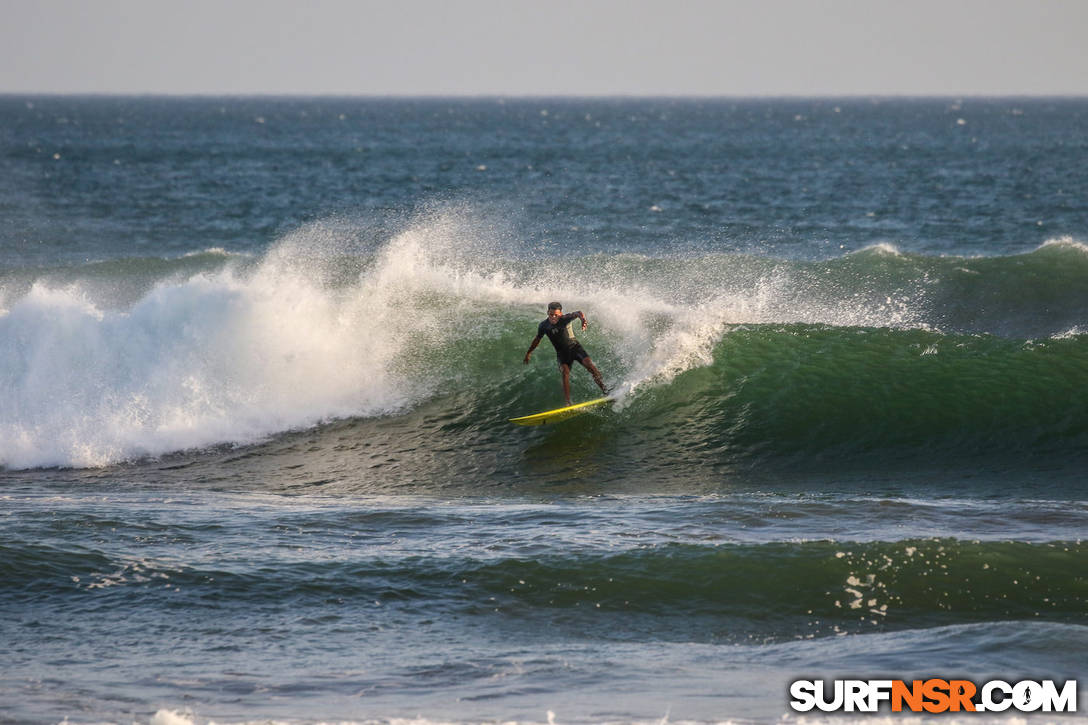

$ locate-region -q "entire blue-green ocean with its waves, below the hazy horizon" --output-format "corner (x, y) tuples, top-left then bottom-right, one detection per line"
(0, 96), (1088, 725)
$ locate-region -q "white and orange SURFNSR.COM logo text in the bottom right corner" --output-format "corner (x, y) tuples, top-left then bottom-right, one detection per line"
(790, 677), (1077, 713)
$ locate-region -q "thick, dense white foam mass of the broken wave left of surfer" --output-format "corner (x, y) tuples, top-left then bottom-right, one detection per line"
(0, 218), (485, 468)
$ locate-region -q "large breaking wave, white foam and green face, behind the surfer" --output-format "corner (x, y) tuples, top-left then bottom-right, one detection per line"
(0, 210), (1088, 468)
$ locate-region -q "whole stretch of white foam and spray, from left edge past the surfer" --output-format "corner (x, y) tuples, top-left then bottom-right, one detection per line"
(0, 209), (935, 468)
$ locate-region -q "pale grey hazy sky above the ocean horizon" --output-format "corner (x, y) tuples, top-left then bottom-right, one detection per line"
(0, 0), (1088, 96)
